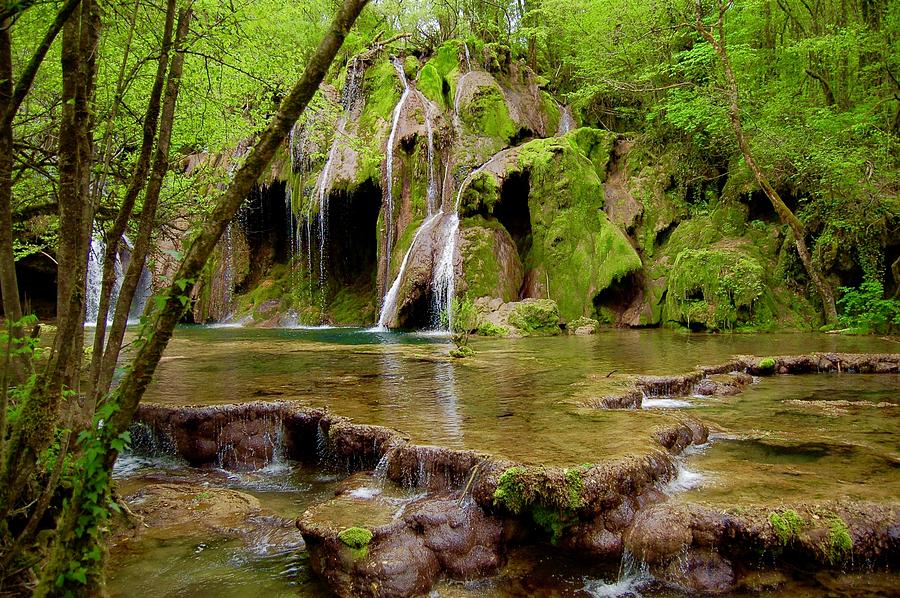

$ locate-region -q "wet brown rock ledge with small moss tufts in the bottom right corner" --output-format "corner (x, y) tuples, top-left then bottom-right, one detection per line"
(625, 502), (900, 592)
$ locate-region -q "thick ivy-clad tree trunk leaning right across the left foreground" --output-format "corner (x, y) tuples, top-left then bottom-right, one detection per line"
(37, 0), (368, 596)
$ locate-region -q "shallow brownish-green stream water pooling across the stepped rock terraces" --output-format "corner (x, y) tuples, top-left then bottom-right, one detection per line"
(109, 326), (900, 597)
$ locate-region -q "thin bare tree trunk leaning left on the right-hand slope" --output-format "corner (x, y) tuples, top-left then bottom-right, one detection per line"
(695, 2), (837, 324)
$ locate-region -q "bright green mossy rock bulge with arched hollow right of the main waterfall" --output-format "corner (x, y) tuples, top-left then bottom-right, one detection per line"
(461, 129), (641, 319)
